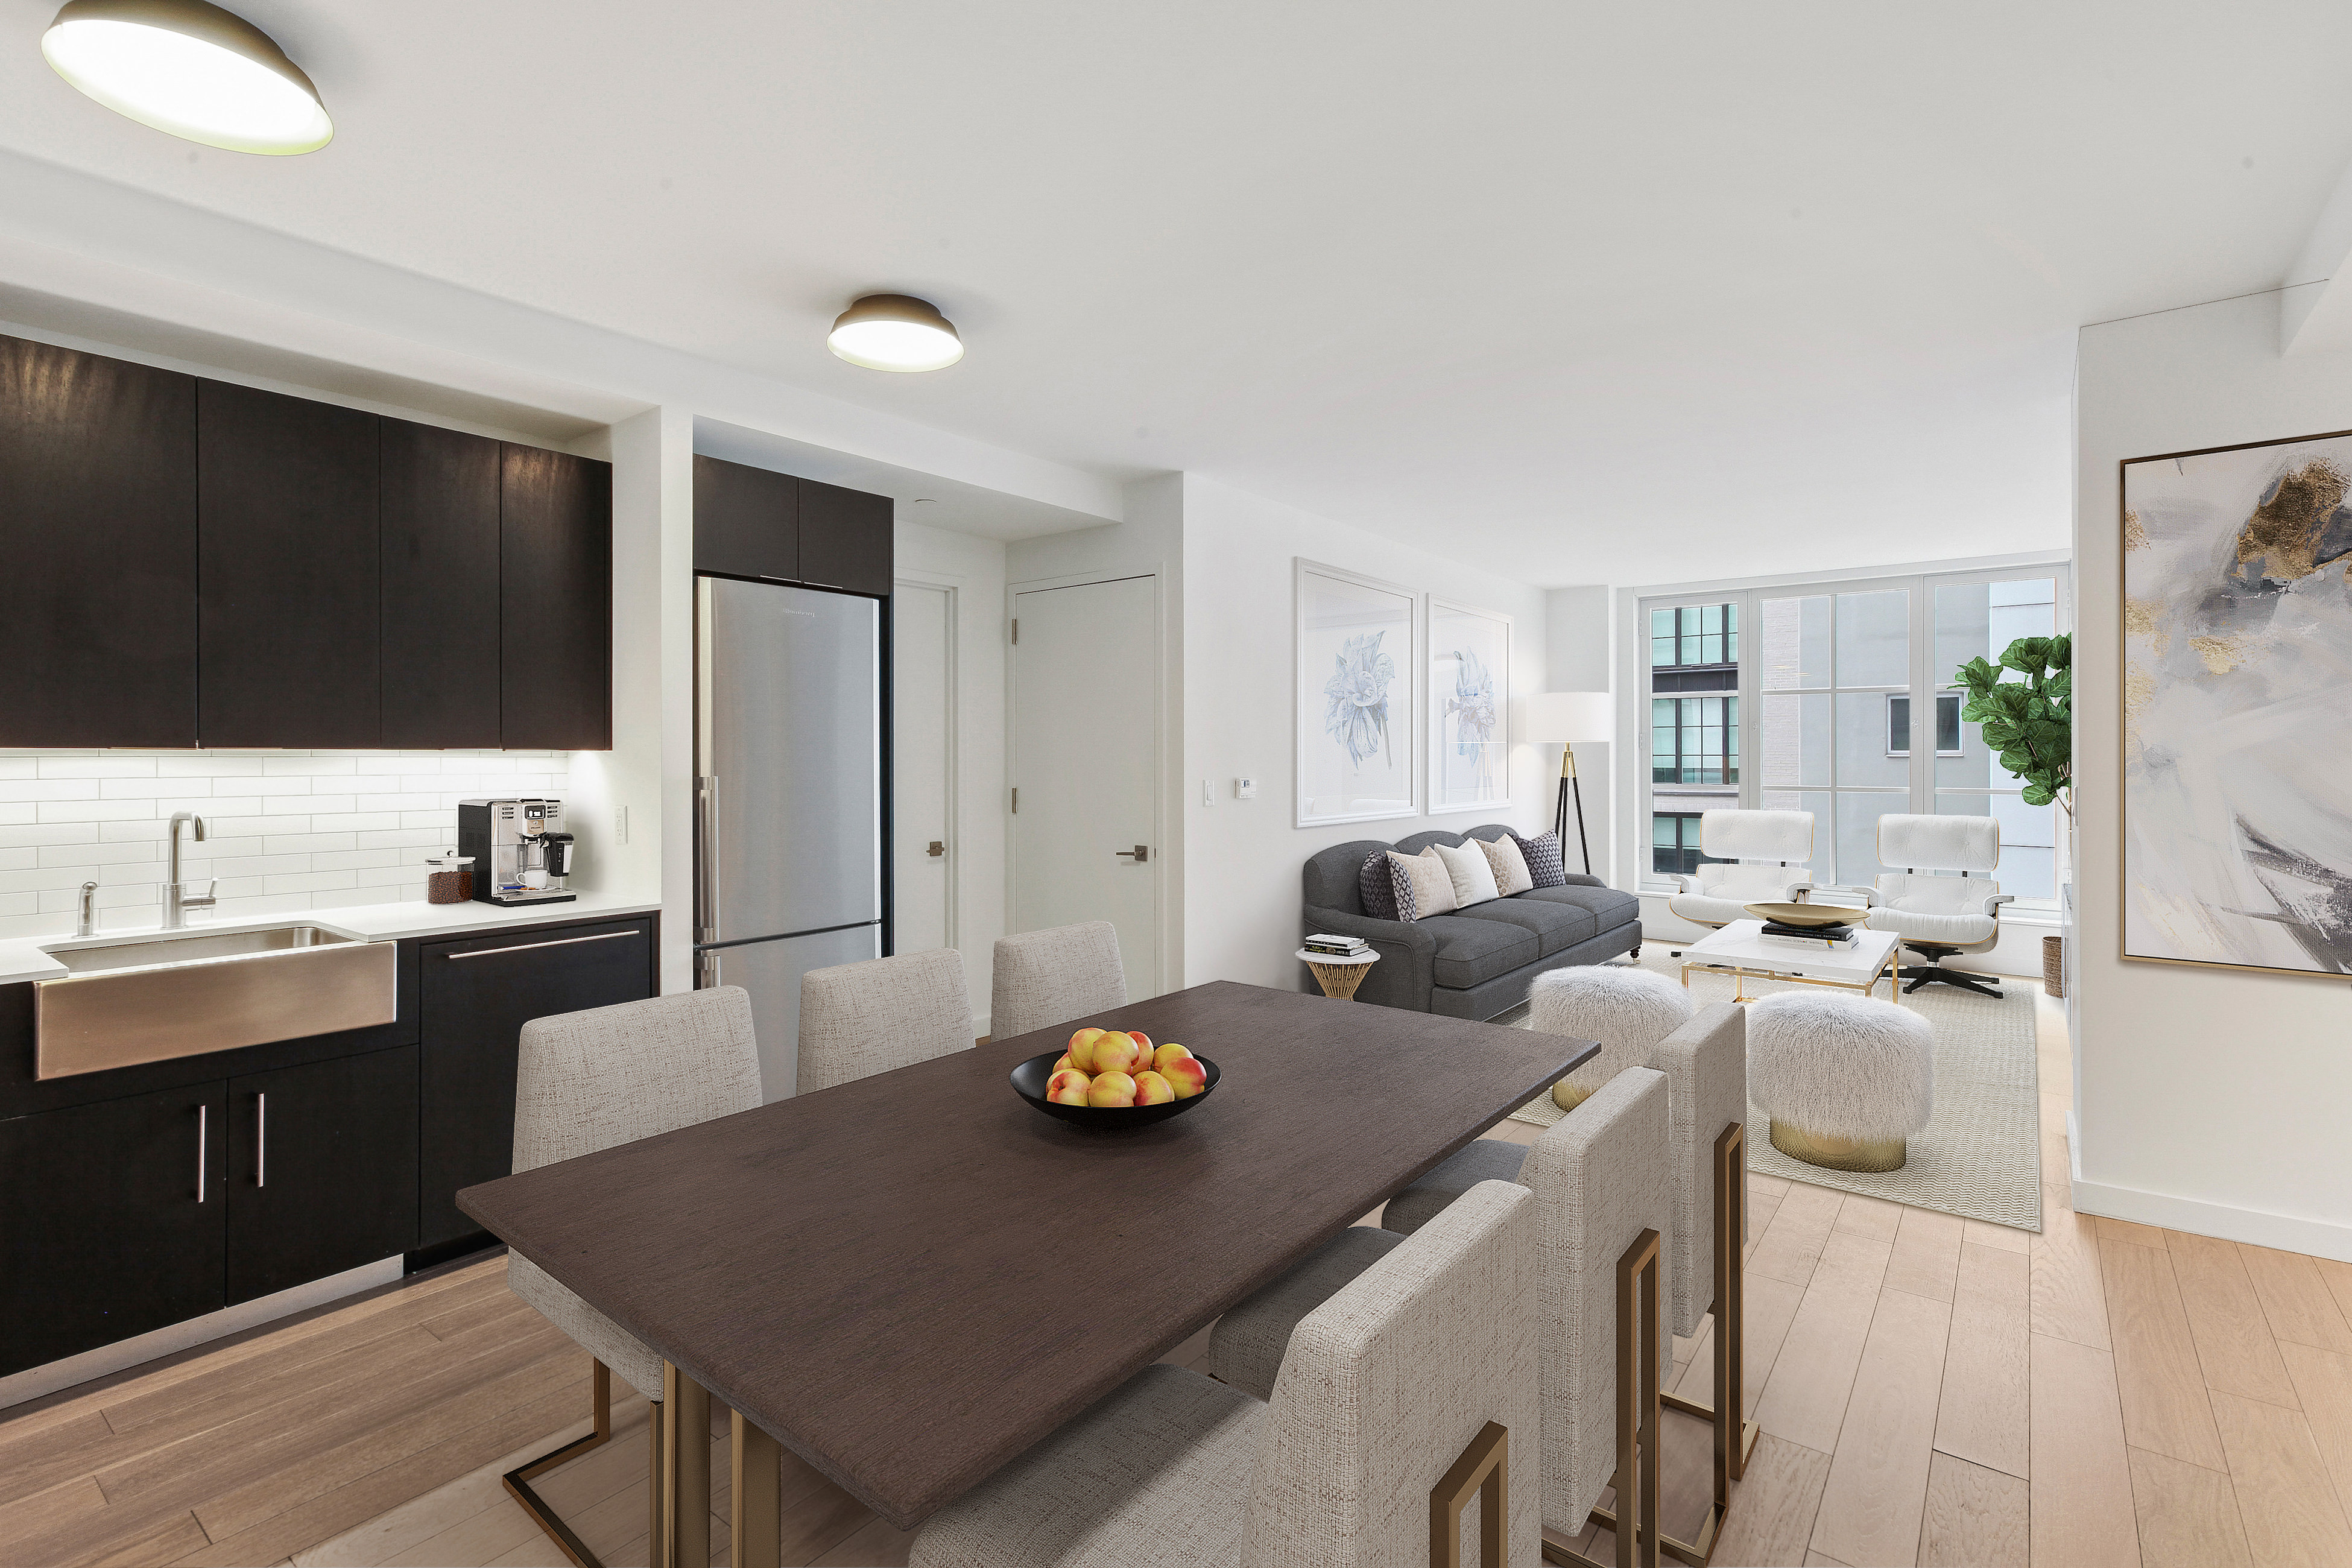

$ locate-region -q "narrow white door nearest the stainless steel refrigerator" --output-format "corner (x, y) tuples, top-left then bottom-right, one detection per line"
(891, 581), (959, 952)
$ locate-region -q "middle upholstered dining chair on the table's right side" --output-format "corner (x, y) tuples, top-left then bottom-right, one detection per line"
(1209, 1067), (1672, 1563)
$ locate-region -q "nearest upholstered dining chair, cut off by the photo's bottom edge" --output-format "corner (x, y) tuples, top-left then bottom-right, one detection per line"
(908, 1184), (1543, 1568)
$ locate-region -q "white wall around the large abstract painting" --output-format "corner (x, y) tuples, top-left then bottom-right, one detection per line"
(2075, 294), (2352, 1260)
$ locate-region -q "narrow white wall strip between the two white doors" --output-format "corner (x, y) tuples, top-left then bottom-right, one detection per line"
(894, 517), (1007, 1034)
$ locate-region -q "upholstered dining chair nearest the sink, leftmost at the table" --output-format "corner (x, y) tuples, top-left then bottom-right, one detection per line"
(504, 985), (760, 1568)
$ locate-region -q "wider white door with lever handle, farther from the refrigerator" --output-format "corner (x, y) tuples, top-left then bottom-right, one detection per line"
(1011, 576), (1162, 999)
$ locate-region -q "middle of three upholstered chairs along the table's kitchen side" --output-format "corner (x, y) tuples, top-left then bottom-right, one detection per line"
(795, 947), (974, 1093)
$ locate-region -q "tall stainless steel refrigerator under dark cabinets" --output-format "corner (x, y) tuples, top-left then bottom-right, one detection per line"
(694, 576), (887, 1100)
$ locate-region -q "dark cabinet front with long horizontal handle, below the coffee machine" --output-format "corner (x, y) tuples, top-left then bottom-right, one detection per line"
(416, 917), (656, 1248)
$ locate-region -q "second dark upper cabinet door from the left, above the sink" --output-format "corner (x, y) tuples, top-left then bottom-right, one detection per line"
(200, 381), (384, 748)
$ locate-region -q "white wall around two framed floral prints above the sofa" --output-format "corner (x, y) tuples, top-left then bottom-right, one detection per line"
(1185, 475), (1573, 992)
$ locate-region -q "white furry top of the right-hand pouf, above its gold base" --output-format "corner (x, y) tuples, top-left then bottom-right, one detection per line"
(1748, 992), (1936, 1140)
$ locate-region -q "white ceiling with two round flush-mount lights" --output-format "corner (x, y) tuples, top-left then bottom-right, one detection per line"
(0, 0), (2352, 583)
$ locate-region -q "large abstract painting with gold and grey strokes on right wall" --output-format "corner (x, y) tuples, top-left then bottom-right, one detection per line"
(2124, 432), (2352, 976)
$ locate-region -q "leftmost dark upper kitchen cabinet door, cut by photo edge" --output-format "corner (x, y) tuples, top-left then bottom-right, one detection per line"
(0, 338), (195, 748)
